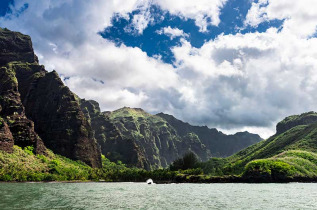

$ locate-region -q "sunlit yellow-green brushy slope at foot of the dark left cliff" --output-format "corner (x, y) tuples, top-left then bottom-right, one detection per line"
(0, 146), (94, 181)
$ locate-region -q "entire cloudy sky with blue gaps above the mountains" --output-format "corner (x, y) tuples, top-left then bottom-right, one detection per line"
(0, 0), (317, 138)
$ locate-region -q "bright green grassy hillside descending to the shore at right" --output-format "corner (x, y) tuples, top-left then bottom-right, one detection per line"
(202, 123), (317, 179)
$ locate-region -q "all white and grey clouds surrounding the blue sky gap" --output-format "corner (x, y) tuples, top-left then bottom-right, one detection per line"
(0, 0), (317, 137)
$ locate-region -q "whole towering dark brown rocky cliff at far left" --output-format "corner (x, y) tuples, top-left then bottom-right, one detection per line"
(0, 30), (101, 167)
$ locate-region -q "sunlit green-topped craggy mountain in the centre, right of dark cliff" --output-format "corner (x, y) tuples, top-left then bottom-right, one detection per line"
(81, 100), (210, 169)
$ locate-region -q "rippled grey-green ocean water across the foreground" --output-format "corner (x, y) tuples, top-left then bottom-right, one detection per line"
(0, 182), (317, 210)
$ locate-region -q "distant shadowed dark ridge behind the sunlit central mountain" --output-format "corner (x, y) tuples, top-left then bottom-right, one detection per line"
(157, 113), (262, 157)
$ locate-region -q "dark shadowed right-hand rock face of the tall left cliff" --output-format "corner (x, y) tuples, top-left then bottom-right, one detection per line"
(12, 63), (101, 167)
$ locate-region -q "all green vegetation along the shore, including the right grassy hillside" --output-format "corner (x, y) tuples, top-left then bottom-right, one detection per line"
(0, 120), (317, 182)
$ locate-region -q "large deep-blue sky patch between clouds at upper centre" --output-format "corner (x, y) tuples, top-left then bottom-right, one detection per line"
(100, 0), (283, 64)
